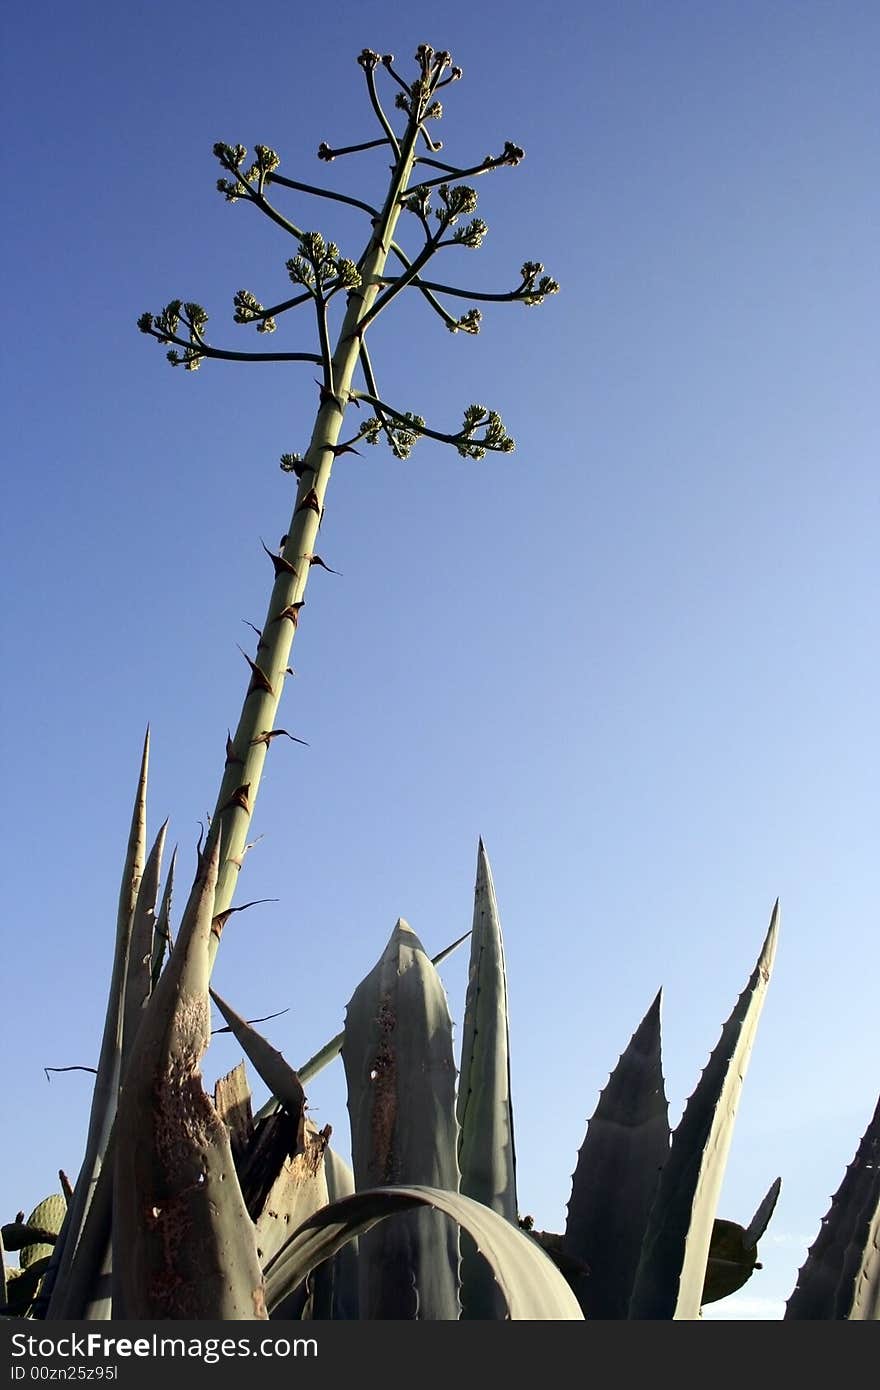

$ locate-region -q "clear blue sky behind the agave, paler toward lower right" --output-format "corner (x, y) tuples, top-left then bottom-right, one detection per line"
(0, 0), (880, 1318)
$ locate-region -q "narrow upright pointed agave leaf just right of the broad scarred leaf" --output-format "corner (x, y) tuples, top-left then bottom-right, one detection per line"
(456, 840), (519, 1319)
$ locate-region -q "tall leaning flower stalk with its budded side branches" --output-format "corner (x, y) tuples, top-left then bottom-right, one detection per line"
(138, 44), (559, 959)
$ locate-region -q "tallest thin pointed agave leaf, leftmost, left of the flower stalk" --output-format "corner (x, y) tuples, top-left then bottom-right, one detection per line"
(43, 728), (150, 1318)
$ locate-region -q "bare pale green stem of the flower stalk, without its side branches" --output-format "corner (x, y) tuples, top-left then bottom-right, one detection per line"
(193, 113), (418, 962)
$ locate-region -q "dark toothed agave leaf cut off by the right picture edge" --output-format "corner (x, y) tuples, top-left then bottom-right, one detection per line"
(784, 1099), (880, 1322)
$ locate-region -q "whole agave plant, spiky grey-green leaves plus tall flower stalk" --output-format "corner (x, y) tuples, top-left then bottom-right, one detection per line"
(0, 46), (880, 1321)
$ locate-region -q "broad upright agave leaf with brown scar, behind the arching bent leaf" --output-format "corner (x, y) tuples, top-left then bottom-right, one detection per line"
(342, 919), (459, 1321)
